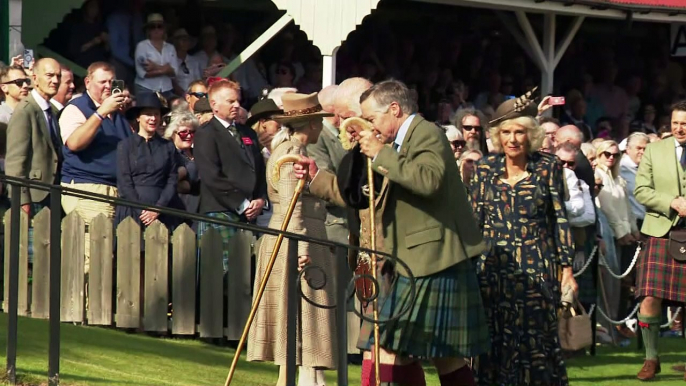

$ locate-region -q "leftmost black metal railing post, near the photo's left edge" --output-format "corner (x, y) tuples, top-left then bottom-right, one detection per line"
(6, 184), (22, 385)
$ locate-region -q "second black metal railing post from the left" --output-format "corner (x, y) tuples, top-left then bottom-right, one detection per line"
(48, 188), (62, 386)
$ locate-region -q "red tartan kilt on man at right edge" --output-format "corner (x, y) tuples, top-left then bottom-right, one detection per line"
(636, 237), (686, 303)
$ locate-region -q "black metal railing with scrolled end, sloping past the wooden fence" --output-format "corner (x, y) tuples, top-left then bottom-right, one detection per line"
(0, 175), (414, 386)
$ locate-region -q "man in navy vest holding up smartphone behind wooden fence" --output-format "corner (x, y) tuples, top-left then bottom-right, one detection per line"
(60, 62), (133, 272)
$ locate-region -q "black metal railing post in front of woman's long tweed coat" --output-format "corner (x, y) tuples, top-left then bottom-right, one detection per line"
(286, 239), (301, 386)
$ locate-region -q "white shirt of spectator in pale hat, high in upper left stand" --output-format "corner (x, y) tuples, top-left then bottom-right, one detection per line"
(134, 39), (179, 92)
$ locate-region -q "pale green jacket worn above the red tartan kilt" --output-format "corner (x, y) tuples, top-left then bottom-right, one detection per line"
(634, 138), (686, 237)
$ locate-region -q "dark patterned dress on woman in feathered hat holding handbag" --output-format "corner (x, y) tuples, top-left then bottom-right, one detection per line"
(471, 152), (574, 386)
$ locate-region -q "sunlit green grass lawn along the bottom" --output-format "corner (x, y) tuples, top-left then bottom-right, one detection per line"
(0, 314), (686, 386)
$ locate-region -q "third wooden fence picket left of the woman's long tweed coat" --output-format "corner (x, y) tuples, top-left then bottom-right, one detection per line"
(171, 224), (198, 335)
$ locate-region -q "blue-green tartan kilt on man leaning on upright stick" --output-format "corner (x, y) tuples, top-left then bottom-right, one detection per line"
(358, 260), (490, 359)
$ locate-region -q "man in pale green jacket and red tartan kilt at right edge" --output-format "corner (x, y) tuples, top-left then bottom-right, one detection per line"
(634, 101), (686, 381)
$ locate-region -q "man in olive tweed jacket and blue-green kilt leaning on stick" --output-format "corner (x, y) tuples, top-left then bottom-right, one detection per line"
(295, 80), (490, 386)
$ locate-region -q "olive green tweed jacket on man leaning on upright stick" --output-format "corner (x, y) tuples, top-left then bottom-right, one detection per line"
(310, 116), (485, 277)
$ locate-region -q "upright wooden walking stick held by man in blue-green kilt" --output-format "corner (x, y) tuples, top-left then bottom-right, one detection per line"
(341, 117), (381, 386)
